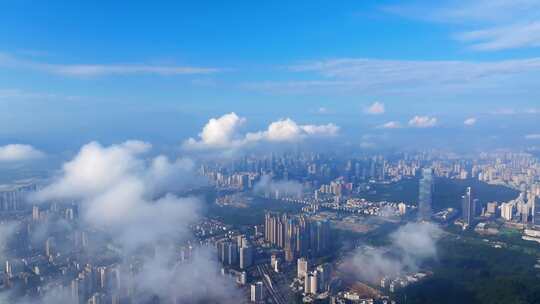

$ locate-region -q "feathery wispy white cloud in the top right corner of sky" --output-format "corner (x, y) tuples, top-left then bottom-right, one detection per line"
(383, 0), (540, 51)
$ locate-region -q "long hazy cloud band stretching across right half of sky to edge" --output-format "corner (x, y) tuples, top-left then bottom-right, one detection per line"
(244, 57), (540, 94)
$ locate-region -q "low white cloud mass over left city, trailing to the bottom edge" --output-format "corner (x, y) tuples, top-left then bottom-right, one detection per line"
(20, 141), (239, 304)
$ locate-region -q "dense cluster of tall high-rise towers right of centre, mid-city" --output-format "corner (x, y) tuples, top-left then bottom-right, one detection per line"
(264, 213), (330, 262)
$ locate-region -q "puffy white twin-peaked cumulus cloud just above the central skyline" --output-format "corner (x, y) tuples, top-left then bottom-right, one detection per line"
(183, 113), (339, 149)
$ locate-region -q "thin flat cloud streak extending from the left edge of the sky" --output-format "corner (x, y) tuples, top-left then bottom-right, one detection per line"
(0, 53), (221, 77)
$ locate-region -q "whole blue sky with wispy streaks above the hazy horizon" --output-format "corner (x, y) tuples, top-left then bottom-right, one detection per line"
(0, 0), (540, 150)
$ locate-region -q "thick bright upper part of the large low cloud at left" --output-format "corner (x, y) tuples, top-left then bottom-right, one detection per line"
(32, 141), (205, 247)
